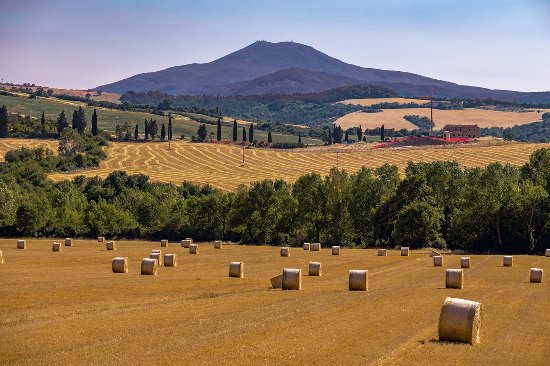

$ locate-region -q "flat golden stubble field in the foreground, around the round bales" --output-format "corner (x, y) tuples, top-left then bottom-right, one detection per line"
(0, 239), (550, 365)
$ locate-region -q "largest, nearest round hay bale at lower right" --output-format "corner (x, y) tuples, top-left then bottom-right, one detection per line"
(438, 297), (481, 344)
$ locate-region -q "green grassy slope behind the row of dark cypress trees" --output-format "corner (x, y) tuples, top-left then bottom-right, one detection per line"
(0, 95), (321, 144)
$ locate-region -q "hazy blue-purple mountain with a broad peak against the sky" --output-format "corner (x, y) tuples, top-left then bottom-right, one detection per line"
(99, 41), (550, 102)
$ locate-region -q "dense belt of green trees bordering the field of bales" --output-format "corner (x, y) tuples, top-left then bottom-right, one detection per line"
(0, 141), (550, 253)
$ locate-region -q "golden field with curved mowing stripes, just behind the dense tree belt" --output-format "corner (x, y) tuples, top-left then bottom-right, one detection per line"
(45, 141), (548, 191)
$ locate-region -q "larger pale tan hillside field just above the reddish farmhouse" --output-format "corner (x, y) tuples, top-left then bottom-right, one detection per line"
(336, 108), (545, 130)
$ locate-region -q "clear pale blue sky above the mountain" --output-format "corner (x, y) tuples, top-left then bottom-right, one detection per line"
(0, 0), (550, 91)
